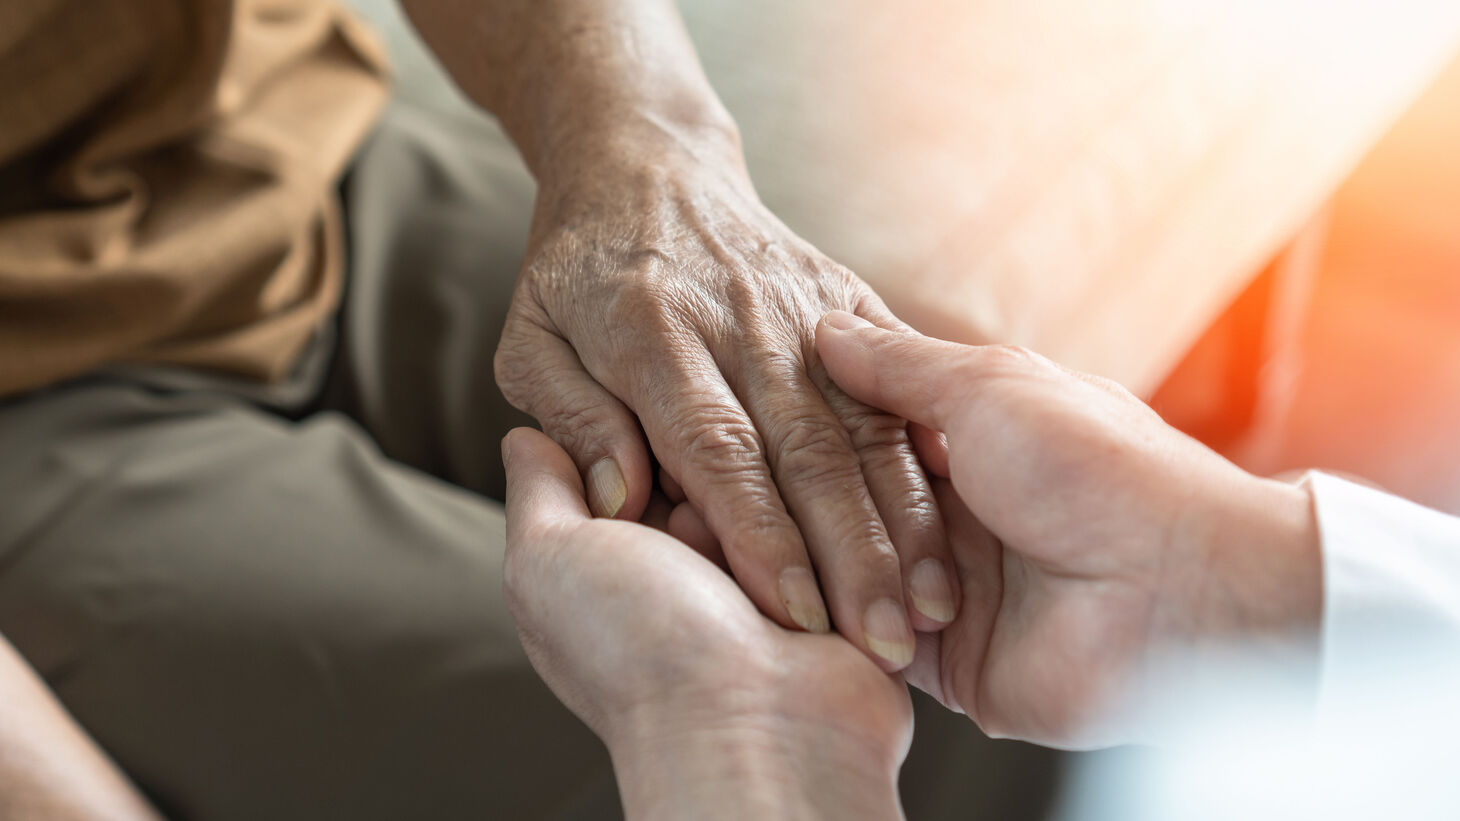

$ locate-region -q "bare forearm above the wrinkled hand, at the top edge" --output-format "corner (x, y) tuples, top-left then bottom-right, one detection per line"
(402, 0), (739, 181)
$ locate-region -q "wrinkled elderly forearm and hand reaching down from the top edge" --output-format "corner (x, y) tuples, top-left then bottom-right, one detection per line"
(403, 0), (959, 669)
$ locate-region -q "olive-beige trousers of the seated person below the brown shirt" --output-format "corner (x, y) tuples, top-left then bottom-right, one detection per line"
(0, 78), (1053, 820)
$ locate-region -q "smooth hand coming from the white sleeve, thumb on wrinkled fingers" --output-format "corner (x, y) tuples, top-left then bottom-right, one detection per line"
(818, 313), (1321, 746)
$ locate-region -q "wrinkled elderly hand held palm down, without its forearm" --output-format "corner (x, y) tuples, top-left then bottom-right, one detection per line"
(496, 126), (959, 671)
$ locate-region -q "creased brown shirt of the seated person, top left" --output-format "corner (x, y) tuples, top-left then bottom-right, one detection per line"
(0, 0), (385, 394)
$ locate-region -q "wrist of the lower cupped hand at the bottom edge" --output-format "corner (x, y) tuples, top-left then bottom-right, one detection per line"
(609, 713), (901, 820)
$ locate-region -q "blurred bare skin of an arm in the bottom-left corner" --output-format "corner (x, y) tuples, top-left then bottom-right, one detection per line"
(0, 628), (161, 821)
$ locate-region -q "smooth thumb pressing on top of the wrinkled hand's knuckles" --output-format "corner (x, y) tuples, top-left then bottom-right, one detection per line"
(816, 311), (980, 431)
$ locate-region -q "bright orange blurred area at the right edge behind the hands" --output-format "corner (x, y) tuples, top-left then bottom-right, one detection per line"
(1153, 47), (1460, 513)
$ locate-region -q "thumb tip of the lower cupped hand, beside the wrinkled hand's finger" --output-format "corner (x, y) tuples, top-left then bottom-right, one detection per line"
(502, 428), (593, 549)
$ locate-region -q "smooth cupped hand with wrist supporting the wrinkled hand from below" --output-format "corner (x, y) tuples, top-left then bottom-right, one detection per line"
(502, 428), (913, 818)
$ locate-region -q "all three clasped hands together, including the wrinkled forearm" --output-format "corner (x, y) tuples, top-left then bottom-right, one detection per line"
(420, 0), (1318, 794)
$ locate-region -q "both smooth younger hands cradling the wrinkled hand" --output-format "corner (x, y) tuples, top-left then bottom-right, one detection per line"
(504, 311), (1321, 815)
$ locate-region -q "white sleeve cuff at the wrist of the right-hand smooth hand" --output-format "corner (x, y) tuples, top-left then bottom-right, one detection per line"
(1304, 472), (1460, 719)
